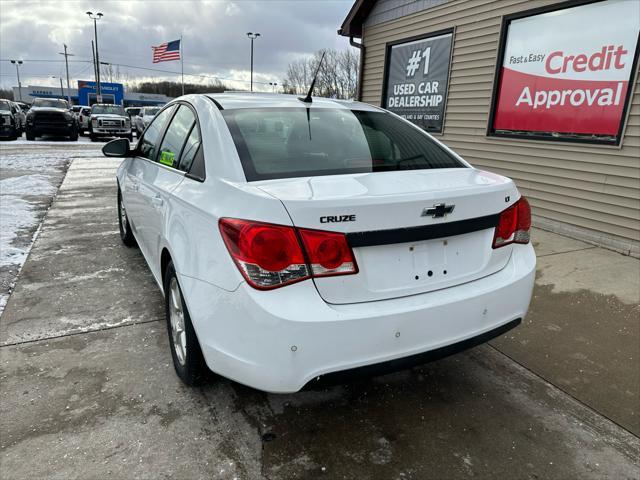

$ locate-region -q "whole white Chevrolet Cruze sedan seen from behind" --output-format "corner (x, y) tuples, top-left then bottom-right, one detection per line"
(103, 94), (536, 392)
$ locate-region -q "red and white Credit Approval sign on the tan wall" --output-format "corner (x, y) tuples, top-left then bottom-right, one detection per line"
(493, 0), (640, 136)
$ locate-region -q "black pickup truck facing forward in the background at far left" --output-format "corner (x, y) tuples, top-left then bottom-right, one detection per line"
(26, 98), (78, 141)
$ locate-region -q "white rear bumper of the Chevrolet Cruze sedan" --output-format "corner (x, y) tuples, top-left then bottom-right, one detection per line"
(179, 245), (536, 393)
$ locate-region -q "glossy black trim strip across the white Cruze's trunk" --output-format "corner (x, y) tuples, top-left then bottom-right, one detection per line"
(347, 213), (500, 248)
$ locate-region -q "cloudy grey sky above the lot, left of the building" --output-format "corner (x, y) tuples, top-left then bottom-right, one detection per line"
(0, 0), (353, 89)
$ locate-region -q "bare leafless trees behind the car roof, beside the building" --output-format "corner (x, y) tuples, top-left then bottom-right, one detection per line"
(282, 49), (358, 98)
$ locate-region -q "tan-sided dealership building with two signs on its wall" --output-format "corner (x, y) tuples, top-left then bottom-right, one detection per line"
(339, 0), (640, 256)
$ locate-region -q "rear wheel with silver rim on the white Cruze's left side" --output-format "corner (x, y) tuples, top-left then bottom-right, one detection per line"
(164, 262), (208, 386)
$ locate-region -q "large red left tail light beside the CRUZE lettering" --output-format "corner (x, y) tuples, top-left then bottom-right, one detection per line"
(219, 218), (358, 289)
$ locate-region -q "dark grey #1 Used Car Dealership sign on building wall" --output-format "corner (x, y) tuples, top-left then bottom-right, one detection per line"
(382, 32), (453, 132)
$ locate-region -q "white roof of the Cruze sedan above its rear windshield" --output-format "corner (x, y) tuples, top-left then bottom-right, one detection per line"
(206, 92), (380, 111)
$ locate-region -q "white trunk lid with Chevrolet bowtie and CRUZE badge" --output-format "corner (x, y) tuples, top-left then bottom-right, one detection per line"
(254, 168), (519, 304)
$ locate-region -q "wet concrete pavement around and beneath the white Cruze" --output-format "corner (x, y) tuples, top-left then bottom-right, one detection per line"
(0, 145), (640, 479)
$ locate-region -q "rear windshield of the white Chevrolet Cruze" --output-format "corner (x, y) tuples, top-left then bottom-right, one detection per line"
(222, 108), (464, 181)
